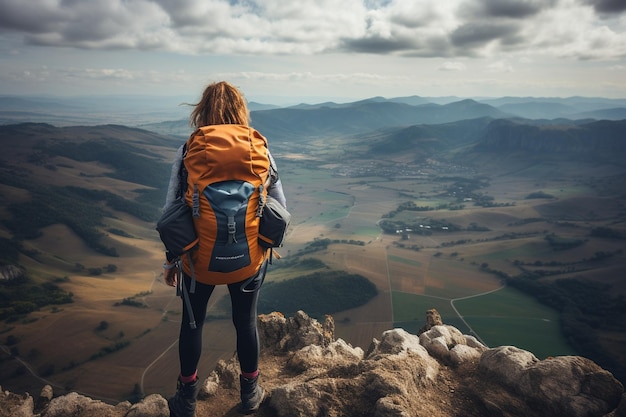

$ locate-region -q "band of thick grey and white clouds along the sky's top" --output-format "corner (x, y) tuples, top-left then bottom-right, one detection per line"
(0, 0), (626, 59)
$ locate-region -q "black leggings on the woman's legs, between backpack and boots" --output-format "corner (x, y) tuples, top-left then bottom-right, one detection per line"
(178, 263), (267, 376)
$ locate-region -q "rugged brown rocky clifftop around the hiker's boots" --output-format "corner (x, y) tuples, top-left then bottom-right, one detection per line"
(0, 311), (626, 417)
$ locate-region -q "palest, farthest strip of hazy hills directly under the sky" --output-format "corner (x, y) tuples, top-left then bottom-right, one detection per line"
(0, 95), (626, 130)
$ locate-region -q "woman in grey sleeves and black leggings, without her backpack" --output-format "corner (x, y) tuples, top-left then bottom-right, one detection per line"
(164, 81), (286, 417)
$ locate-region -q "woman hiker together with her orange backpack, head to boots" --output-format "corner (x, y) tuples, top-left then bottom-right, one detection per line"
(164, 82), (286, 417)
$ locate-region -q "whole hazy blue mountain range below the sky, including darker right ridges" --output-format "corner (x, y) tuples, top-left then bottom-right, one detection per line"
(0, 95), (626, 164)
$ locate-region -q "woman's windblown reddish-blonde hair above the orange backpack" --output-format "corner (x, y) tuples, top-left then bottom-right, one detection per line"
(189, 81), (250, 128)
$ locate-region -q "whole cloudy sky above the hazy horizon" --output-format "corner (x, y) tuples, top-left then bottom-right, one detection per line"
(0, 0), (626, 104)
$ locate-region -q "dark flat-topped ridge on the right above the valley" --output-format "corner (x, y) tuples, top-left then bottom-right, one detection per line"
(346, 117), (626, 164)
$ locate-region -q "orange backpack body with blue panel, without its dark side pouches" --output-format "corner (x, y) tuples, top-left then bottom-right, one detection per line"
(182, 125), (270, 285)
